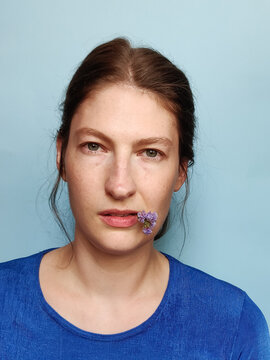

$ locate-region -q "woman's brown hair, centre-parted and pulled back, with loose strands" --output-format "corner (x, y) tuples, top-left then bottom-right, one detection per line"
(50, 38), (195, 245)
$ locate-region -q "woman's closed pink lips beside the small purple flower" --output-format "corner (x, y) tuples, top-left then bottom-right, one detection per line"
(99, 209), (138, 228)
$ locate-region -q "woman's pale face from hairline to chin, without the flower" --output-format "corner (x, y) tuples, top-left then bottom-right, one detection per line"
(57, 85), (185, 254)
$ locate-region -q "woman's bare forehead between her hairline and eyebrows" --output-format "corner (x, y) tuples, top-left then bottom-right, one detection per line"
(71, 84), (178, 140)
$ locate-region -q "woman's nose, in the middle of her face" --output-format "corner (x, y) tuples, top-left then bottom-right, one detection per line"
(105, 159), (136, 200)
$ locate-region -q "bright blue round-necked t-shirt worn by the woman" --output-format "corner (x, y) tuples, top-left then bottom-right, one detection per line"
(0, 248), (270, 360)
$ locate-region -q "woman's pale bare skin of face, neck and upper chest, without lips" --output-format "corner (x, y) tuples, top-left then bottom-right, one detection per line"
(39, 84), (186, 334)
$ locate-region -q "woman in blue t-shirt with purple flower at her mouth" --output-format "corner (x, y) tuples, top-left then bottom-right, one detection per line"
(0, 38), (270, 360)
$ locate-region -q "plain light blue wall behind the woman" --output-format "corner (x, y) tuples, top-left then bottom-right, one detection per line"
(0, 0), (270, 323)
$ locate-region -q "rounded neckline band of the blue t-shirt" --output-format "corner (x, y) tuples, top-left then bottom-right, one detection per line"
(35, 247), (175, 341)
